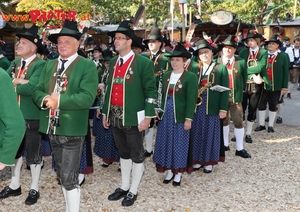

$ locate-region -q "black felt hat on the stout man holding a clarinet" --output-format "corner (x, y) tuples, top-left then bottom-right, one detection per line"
(48, 20), (81, 43)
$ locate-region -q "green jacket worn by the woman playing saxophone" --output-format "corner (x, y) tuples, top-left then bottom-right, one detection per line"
(193, 63), (229, 115)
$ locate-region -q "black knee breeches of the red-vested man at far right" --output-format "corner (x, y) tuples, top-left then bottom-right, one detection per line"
(258, 90), (281, 112)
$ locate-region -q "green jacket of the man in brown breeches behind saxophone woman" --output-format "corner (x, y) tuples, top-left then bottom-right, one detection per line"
(216, 55), (247, 103)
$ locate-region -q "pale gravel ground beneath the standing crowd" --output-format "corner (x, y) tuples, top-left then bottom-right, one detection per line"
(0, 121), (300, 212)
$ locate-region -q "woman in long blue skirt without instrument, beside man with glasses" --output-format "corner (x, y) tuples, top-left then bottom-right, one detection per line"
(153, 44), (197, 186)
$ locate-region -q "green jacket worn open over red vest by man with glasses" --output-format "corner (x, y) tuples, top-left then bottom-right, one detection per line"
(103, 54), (157, 126)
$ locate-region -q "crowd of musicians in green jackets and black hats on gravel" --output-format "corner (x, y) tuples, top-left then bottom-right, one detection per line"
(0, 20), (292, 212)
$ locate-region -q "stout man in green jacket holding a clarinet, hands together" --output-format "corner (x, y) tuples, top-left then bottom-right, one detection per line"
(33, 21), (98, 212)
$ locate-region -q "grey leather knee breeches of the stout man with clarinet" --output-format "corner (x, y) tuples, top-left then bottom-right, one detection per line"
(49, 135), (84, 191)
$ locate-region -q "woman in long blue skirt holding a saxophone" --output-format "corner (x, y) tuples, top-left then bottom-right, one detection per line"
(191, 40), (229, 173)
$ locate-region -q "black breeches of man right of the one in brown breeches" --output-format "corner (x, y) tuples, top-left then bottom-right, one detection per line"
(243, 83), (263, 122)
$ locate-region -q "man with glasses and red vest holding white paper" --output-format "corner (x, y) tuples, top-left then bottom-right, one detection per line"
(103, 20), (157, 206)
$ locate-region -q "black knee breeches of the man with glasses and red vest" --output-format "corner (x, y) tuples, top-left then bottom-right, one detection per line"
(110, 113), (145, 163)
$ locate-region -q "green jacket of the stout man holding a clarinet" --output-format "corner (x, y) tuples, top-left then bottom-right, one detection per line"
(33, 56), (98, 136)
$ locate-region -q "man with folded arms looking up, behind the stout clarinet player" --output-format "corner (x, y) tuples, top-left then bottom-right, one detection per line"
(0, 25), (45, 205)
